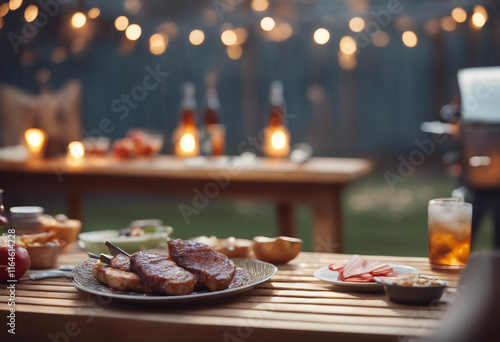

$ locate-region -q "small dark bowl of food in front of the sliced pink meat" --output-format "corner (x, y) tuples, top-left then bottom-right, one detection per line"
(375, 276), (448, 305)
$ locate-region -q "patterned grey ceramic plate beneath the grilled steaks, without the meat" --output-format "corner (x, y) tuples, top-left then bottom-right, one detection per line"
(73, 259), (278, 303)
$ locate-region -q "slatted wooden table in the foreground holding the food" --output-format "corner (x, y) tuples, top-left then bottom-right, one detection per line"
(0, 252), (458, 342)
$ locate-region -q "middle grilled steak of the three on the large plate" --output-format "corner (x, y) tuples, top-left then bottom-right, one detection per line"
(130, 252), (196, 295)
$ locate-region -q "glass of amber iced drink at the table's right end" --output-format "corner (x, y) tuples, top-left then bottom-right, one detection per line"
(428, 198), (472, 270)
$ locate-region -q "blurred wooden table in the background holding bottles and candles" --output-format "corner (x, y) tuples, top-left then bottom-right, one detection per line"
(0, 156), (371, 252)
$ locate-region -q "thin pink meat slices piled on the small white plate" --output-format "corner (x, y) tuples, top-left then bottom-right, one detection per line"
(329, 255), (398, 283)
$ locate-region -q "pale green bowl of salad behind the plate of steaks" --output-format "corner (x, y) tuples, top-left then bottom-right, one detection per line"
(78, 220), (173, 254)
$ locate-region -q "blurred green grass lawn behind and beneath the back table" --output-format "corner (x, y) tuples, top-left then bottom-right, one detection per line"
(38, 169), (492, 256)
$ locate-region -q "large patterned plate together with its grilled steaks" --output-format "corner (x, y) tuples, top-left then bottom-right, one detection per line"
(73, 240), (278, 302)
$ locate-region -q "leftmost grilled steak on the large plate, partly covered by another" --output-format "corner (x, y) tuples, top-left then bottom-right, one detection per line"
(92, 256), (151, 293)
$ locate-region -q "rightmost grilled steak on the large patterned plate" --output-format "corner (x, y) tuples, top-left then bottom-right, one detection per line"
(168, 240), (236, 291)
